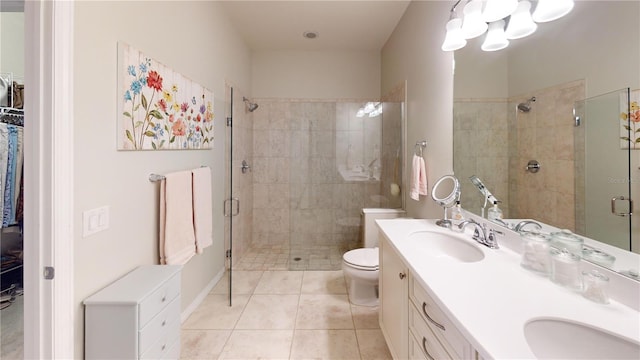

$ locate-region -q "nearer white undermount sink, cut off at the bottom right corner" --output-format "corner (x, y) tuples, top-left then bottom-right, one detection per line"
(524, 318), (640, 359)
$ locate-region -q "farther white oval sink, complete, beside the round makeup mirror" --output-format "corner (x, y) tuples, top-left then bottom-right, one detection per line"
(407, 231), (484, 262)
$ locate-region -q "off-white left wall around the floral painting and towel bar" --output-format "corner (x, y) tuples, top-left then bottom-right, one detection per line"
(74, 1), (251, 358)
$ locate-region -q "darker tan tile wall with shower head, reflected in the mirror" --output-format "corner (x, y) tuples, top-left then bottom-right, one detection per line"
(509, 80), (585, 231)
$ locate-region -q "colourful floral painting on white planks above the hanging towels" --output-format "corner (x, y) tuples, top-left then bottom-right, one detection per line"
(118, 43), (214, 150)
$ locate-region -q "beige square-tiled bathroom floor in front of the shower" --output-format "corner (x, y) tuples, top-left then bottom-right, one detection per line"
(181, 270), (391, 360)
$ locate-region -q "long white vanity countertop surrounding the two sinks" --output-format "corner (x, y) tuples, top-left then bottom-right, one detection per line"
(377, 219), (640, 359)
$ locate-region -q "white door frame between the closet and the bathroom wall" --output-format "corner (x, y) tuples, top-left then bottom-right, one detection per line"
(24, 0), (76, 359)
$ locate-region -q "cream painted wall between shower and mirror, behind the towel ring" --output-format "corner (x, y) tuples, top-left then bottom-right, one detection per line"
(382, 1), (453, 218)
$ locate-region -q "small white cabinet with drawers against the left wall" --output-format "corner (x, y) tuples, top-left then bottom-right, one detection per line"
(84, 265), (182, 359)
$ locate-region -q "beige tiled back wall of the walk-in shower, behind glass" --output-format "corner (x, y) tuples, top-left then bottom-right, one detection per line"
(252, 99), (395, 269)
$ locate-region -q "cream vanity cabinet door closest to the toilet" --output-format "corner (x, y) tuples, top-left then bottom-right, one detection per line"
(379, 235), (409, 359)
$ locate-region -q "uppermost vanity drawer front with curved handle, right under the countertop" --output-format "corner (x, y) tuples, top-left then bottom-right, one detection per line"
(409, 277), (472, 359)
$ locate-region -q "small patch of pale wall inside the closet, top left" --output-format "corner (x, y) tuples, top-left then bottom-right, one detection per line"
(0, 12), (24, 79)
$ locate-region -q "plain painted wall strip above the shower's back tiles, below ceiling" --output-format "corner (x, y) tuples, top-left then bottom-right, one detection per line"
(251, 50), (380, 99)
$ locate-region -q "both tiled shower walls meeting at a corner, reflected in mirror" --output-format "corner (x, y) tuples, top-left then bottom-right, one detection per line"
(454, 80), (585, 231)
